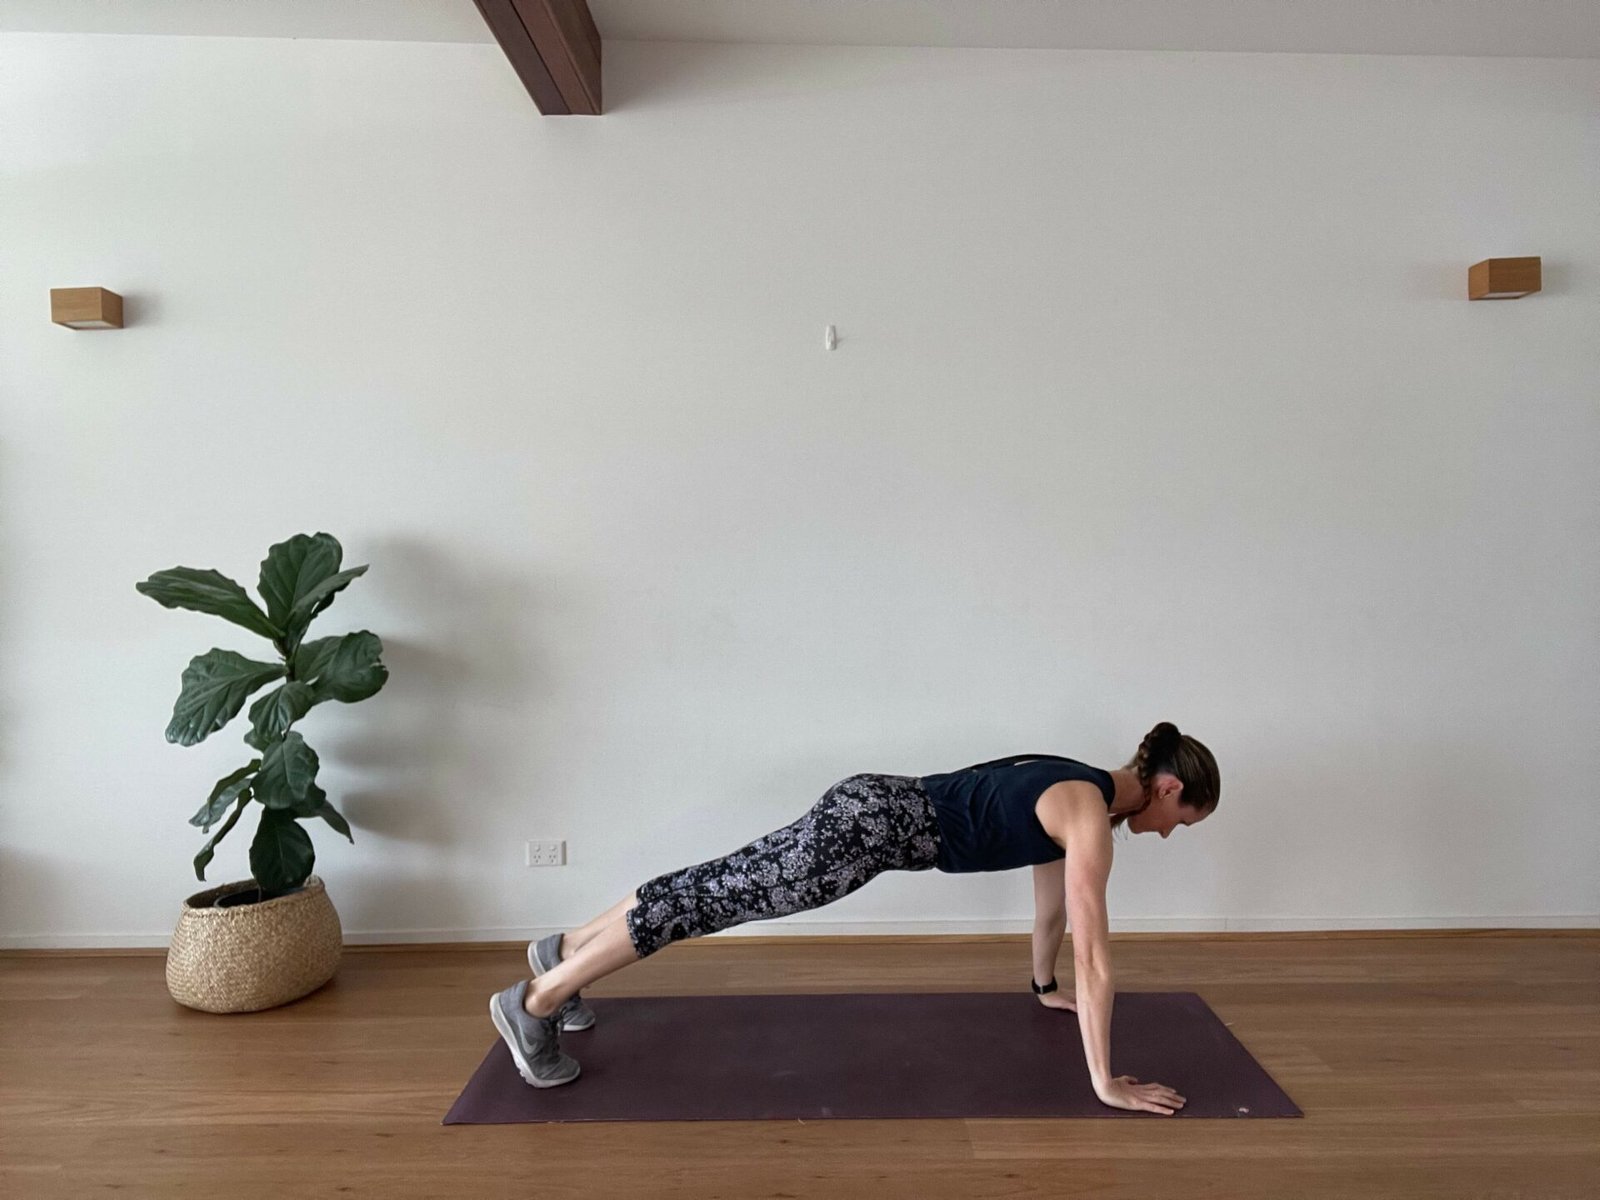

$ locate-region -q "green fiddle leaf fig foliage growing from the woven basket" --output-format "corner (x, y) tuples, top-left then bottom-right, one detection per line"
(134, 533), (389, 899)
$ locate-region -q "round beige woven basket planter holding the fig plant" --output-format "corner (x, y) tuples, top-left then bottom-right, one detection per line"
(166, 875), (344, 1013)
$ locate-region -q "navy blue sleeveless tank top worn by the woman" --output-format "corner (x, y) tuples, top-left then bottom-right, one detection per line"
(920, 754), (1117, 872)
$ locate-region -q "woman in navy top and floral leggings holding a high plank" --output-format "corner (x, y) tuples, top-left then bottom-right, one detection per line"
(490, 722), (1221, 1117)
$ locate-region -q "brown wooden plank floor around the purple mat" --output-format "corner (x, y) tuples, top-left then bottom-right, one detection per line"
(0, 931), (1600, 1200)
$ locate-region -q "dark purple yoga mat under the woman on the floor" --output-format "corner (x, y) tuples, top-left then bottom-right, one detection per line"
(443, 992), (1302, 1125)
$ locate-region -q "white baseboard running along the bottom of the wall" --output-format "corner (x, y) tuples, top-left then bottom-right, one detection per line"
(0, 914), (1600, 950)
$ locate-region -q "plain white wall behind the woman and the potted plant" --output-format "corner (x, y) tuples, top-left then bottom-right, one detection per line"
(0, 35), (1600, 946)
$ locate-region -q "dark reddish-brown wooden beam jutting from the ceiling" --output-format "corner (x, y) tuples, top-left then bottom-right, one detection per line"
(474, 0), (602, 117)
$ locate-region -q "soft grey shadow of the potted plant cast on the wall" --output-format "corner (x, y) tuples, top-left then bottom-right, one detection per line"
(315, 538), (547, 931)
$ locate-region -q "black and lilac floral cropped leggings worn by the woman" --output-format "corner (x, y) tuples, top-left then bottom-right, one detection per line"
(626, 774), (939, 958)
